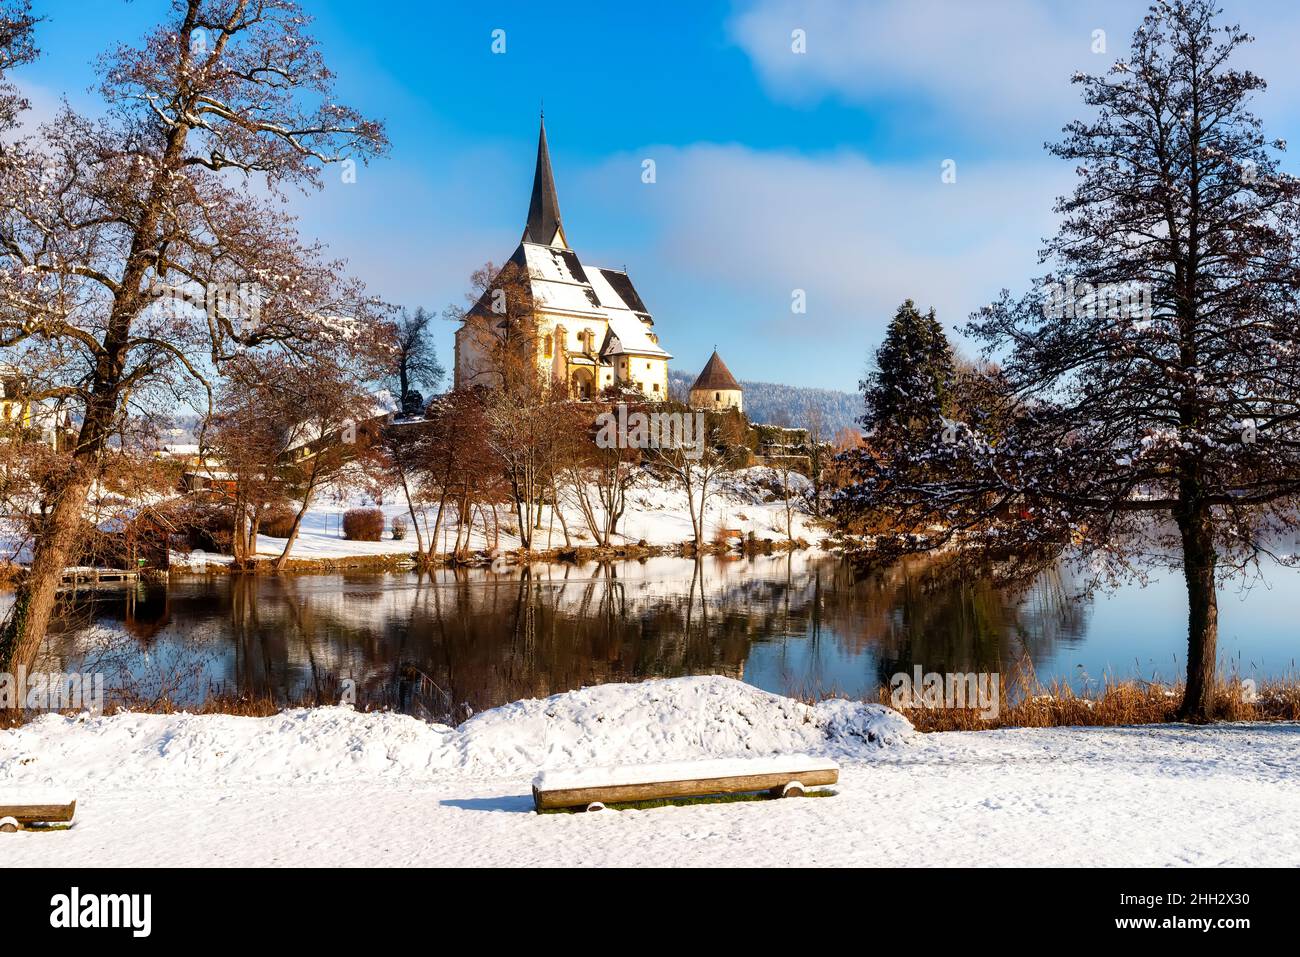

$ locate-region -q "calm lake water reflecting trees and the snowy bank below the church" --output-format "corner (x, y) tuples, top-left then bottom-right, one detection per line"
(25, 555), (1300, 719)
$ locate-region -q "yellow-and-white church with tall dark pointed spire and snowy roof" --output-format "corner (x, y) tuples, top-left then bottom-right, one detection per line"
(455, 117), (672, 399)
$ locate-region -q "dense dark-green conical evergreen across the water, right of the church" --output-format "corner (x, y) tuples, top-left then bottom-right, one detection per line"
(859, 299), (956, 441)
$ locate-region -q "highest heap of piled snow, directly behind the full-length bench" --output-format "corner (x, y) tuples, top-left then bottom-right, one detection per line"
(458, 675), (914, 771)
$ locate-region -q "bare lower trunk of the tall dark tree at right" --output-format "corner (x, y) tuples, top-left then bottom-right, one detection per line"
(1178, 506), (1218, 722)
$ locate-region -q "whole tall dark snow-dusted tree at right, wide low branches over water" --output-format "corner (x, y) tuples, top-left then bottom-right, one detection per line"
(841, 0), (1300, 720)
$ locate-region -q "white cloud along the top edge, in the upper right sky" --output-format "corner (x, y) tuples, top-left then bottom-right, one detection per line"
(728, 0), (1300, 142)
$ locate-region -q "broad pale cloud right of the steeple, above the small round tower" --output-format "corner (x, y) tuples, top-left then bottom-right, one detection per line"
(571, 144), (1073, 387)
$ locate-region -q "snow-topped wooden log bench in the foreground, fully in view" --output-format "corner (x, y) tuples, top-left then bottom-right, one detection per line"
(533, 754), (840, 811)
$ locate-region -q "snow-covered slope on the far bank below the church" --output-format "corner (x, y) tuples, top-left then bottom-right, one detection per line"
(173, 465), (826, 564)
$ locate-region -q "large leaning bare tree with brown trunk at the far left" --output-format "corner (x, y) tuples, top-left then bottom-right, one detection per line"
(0, 0), (386, 670)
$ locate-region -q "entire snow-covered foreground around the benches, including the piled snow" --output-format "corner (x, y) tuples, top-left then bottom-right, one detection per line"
(0, 676), (1300, 866)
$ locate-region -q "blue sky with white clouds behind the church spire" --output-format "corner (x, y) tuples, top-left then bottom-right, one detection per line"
(17, 0), (1300, 390)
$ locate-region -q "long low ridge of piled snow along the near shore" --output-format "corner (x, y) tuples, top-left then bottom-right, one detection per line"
(0, 676), (913, 797)
